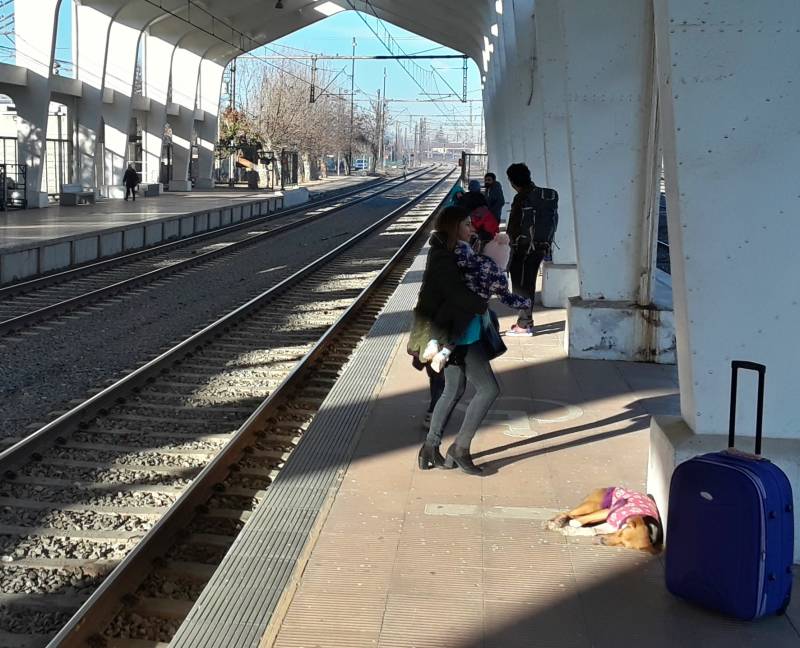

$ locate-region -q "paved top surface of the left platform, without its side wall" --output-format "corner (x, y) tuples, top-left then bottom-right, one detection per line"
(0, 176), (372, 252)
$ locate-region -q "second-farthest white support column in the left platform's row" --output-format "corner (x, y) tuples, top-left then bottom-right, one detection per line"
(169, 45), (202, 191)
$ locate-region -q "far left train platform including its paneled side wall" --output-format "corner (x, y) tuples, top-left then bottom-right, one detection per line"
(0, 176), (375, 284)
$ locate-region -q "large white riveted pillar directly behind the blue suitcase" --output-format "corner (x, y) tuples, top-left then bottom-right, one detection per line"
(648, 0), (800, 562)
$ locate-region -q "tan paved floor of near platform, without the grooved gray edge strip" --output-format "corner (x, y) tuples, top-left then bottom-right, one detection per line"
(262, 310), (800, 648)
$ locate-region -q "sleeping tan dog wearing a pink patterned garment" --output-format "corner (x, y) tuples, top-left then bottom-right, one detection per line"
(546, 486), (664, 554)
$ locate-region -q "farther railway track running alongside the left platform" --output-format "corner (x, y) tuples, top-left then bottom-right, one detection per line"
(0, 169), (428, 336)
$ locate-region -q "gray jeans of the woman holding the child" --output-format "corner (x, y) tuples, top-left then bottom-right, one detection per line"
(425, 342), (500, 448)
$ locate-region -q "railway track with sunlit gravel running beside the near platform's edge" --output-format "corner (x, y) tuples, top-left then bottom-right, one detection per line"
(0, 166), (448, 648)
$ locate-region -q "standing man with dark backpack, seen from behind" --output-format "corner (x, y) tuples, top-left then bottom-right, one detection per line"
(506, 162), (558, 336)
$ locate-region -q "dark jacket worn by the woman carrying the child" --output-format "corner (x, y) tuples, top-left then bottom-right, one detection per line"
(408, 232), (487, 354)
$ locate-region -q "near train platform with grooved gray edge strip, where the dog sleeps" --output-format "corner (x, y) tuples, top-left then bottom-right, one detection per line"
(170, 240), (800, 648)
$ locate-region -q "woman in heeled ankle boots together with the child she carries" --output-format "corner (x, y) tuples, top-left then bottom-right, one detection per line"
(408, 207), (532, 475)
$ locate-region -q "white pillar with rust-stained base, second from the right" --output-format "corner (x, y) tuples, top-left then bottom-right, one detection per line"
(558, 0), (674, 362)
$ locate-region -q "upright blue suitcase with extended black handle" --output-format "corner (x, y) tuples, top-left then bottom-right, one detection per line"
(666, 361), (794, 619)
